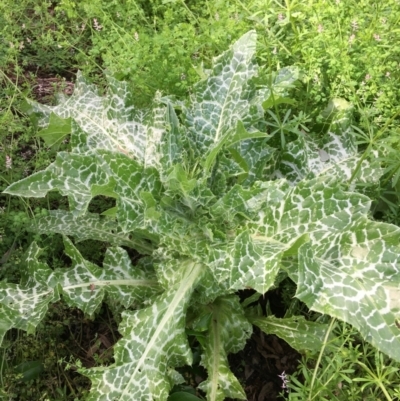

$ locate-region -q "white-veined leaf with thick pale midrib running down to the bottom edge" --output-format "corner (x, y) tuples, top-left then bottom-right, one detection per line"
(81, 262), (206, 401)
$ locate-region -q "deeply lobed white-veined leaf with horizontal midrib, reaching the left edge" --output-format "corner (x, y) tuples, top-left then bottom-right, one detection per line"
(0, 237), (161, 339)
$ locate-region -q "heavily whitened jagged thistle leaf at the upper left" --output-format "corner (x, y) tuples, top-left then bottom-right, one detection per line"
(25, 72), (165, 167)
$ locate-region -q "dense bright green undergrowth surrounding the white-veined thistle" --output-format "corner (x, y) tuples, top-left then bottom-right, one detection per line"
(0, 0), (400, 400)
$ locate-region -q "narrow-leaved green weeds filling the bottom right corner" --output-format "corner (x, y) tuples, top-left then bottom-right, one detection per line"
(287, 319), (400, 401)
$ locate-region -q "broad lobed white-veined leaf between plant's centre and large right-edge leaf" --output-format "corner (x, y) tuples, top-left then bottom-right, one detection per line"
(207, 178), (370, 293)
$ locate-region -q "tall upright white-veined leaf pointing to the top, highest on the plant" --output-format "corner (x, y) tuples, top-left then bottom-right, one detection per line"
(183, 31), (266, 170)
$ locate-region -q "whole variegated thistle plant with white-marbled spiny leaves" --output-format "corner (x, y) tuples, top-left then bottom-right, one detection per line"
(0, 31), (400, 401)
